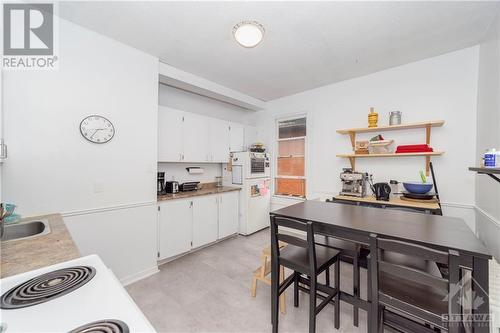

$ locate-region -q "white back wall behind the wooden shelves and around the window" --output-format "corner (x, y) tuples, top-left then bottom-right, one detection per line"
(253, 47), (478, 231)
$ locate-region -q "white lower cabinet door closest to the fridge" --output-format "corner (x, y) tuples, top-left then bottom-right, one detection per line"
(219, 191), (239, 239)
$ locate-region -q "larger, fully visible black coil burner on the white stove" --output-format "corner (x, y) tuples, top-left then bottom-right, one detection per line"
(0, 266), (96, 309)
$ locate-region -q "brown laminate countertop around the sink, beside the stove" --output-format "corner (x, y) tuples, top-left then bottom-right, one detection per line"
(0, 214), (80, 278)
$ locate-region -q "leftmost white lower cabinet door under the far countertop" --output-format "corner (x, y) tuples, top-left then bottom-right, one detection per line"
(158, 200), (193, 259)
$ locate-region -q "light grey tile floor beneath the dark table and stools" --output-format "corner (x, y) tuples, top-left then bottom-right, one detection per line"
(127, 230), (367, 333)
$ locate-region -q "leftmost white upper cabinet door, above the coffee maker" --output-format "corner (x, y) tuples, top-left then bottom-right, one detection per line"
(158, 106), (184, 162)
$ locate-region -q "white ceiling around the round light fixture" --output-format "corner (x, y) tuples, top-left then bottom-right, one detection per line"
(59, 1), (497, 101)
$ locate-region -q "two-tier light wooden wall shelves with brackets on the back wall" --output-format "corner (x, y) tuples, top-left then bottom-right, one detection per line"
(337, 120), (444, 176)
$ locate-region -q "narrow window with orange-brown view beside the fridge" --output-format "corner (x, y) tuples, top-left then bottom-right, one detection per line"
(275, 117), (306, 198)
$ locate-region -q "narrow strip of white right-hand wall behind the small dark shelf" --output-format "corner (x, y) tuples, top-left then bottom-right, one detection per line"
(475, 9), (500, 260)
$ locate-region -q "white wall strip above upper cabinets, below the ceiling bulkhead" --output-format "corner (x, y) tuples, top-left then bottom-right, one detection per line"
(159, 84), (255, 124)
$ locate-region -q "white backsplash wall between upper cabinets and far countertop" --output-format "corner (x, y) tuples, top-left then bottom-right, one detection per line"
(158, 163), (222, 183)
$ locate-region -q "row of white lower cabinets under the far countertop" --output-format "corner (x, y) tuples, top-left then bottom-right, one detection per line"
(158, 191), (239, 260)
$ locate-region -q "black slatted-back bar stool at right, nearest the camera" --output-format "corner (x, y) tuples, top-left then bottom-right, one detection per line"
(370, 234), (462, 333)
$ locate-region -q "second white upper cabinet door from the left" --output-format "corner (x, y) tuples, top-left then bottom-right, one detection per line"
(183, 112), (210, 162)
